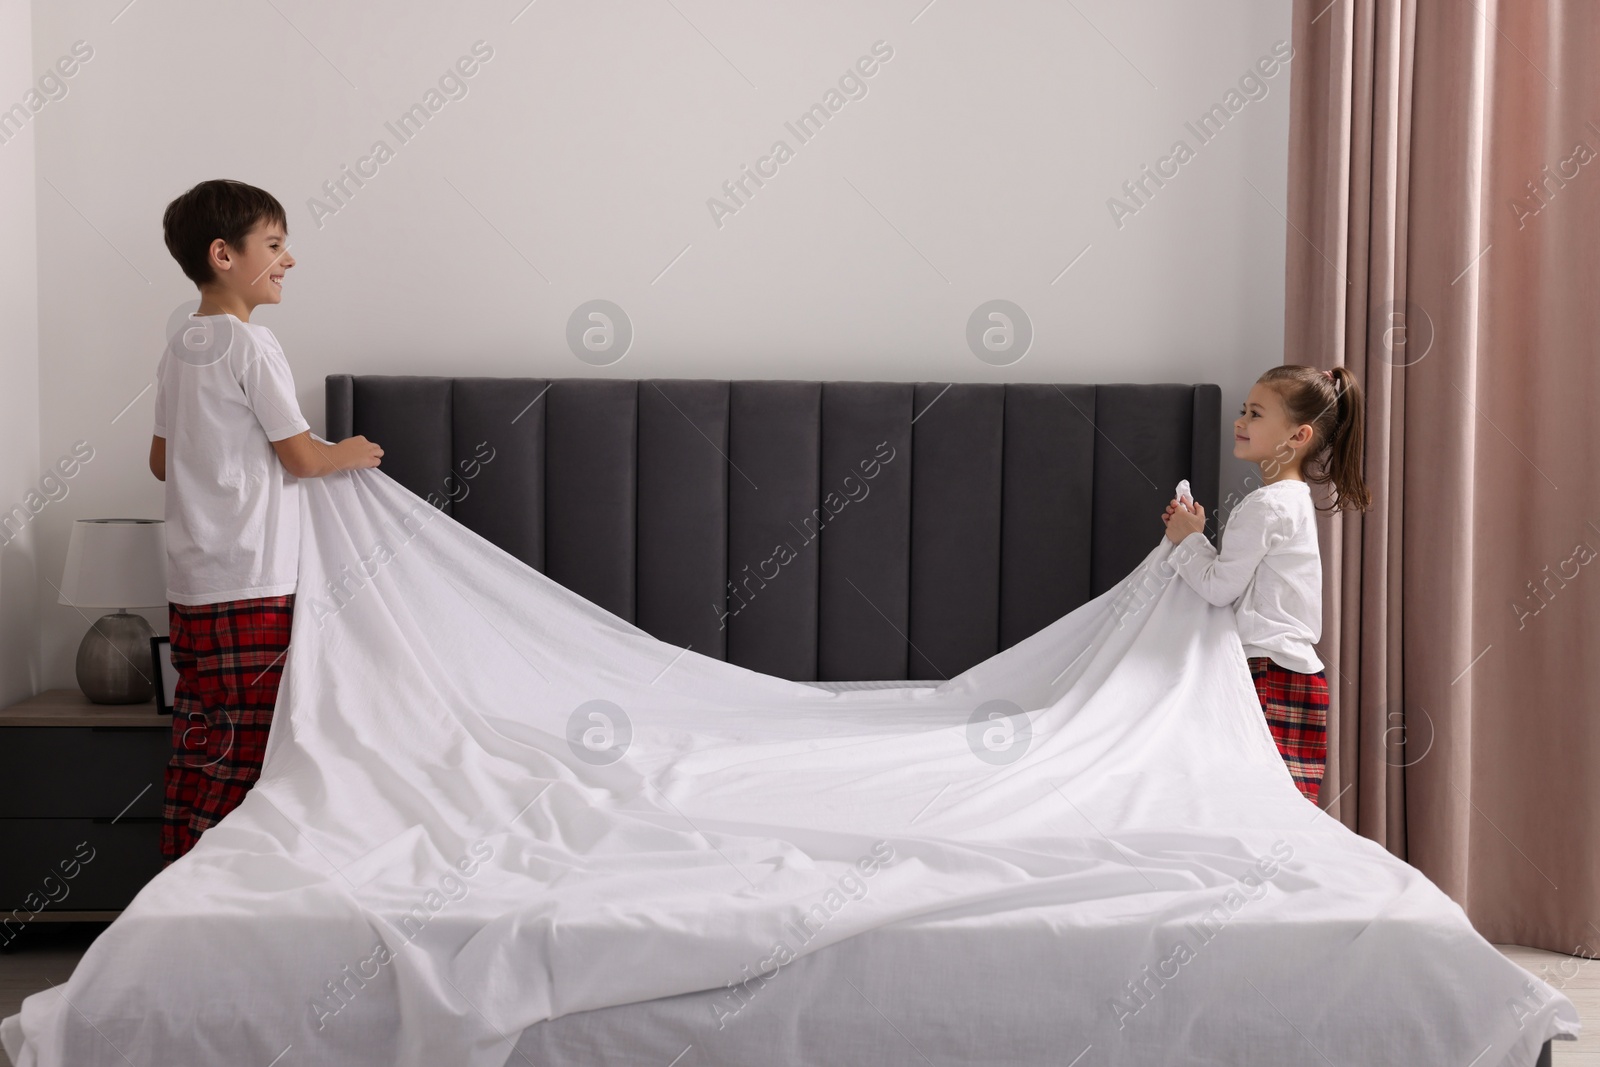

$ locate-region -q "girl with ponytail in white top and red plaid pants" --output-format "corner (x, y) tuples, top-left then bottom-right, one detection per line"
(1162, 365), (1370, 803)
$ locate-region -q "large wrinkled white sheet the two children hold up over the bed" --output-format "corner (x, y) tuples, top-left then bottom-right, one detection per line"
(0, 470), (1578, 1067)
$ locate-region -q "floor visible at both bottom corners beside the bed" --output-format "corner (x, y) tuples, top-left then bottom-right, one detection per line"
(0, 923), (1600, 1067)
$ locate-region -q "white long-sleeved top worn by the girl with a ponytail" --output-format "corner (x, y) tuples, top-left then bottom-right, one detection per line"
(1171, 478), (1323, 673)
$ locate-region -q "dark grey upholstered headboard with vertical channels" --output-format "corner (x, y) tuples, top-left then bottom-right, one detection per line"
(326, 374), (1221, 681)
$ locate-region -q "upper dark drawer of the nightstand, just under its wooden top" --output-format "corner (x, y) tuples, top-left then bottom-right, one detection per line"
(0, 720), (171, 819)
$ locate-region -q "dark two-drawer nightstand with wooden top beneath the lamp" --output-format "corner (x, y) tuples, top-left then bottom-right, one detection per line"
(0, 689), (173, 927)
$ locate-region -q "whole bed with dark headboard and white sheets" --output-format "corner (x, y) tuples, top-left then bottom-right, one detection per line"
(0, 378), (1581, 1067)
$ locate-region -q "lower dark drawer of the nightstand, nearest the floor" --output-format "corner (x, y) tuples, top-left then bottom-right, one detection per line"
(0, 817), (162, 908)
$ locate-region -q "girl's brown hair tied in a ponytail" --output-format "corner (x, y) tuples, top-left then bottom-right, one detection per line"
(1256, 363), (1371, 512)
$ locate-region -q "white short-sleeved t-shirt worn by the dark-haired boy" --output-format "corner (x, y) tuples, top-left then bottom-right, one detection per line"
(155, 315), (310, 605)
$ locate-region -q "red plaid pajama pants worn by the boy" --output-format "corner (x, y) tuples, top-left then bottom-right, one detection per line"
(162, 593), (294, 864)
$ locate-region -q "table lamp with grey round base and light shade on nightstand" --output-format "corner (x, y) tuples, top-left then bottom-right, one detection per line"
(61, 518), (166, 704)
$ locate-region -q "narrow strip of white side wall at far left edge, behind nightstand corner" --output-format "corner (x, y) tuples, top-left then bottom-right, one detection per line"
(0, 0), (41, 707)
